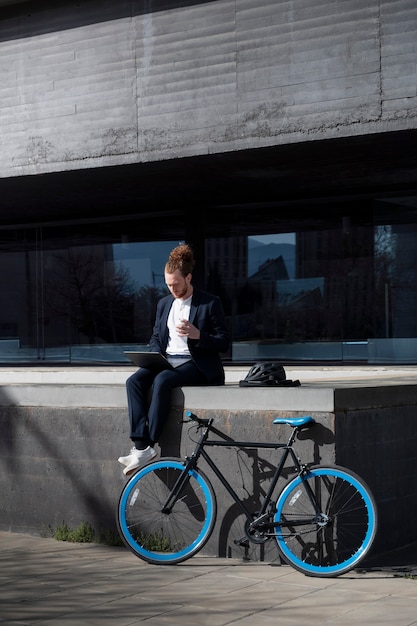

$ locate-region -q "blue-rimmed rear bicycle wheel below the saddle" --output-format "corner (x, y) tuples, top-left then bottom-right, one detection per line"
(274, 466), (377, 577)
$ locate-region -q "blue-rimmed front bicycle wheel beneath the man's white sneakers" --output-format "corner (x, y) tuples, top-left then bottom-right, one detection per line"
(117, 459), (217, 565)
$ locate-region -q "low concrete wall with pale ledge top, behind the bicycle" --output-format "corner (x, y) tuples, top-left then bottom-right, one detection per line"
(0, 368), (417, 561)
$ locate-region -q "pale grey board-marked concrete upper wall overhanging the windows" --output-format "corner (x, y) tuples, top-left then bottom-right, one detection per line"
(0, 0), (417, 177)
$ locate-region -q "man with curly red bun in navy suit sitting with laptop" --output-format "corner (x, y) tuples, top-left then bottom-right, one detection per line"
(118, 244), (229, 476)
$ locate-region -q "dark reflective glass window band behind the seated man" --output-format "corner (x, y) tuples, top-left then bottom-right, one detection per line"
(0, 198), (417, 364)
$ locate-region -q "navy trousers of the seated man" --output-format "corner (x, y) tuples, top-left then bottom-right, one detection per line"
(126, 361), (206, 446)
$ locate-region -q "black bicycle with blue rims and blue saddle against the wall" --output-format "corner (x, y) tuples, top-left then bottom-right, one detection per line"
(117, 412), (377, 577)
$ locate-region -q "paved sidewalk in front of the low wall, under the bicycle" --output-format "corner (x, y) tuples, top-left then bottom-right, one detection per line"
(0, 532), (417, 626)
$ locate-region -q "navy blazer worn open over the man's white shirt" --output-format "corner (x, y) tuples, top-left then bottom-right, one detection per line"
(149, 289), (229, 385)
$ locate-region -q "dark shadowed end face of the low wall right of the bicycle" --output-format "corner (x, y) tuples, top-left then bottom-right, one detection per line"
(335, 384), (417, 546)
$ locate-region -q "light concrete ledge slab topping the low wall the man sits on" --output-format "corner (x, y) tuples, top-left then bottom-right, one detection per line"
(0, 366), (417, 412)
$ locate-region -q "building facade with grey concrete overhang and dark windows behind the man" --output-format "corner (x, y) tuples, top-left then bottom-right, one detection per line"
(0, 0), (417, 363)
